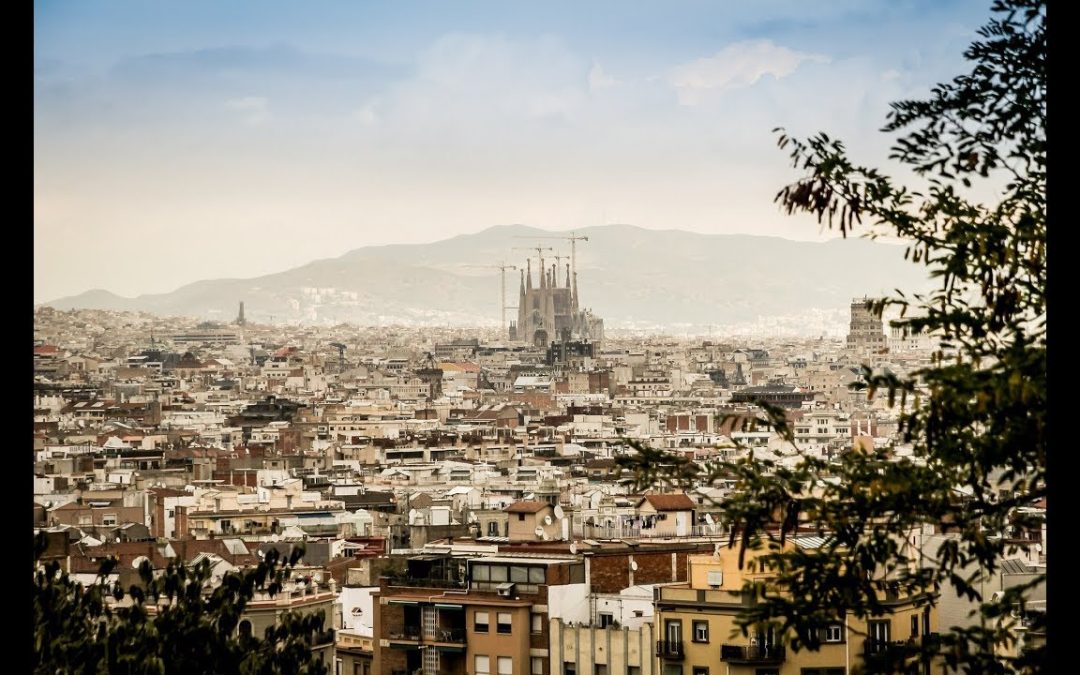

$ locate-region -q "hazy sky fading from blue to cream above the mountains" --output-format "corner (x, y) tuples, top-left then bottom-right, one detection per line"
(33, 0), (989, 301)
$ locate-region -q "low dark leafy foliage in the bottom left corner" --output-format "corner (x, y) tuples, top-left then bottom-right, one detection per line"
(31, 535), (327, 675)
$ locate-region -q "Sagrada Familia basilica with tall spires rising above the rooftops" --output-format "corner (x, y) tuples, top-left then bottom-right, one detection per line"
(510, 253), (604, 348)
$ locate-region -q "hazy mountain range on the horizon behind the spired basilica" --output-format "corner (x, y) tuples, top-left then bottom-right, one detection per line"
(44, 225), (929, 326)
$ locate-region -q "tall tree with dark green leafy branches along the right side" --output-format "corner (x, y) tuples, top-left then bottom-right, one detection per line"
(622, 0), (1047, 672)
